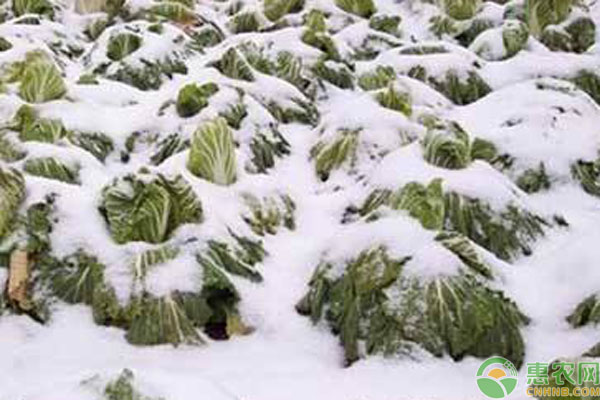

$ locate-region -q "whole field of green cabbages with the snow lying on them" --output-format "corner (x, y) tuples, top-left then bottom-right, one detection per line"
(0, 0), (600, 384)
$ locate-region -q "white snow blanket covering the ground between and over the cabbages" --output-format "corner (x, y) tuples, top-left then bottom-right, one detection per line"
(0, 0), (600, 400)
